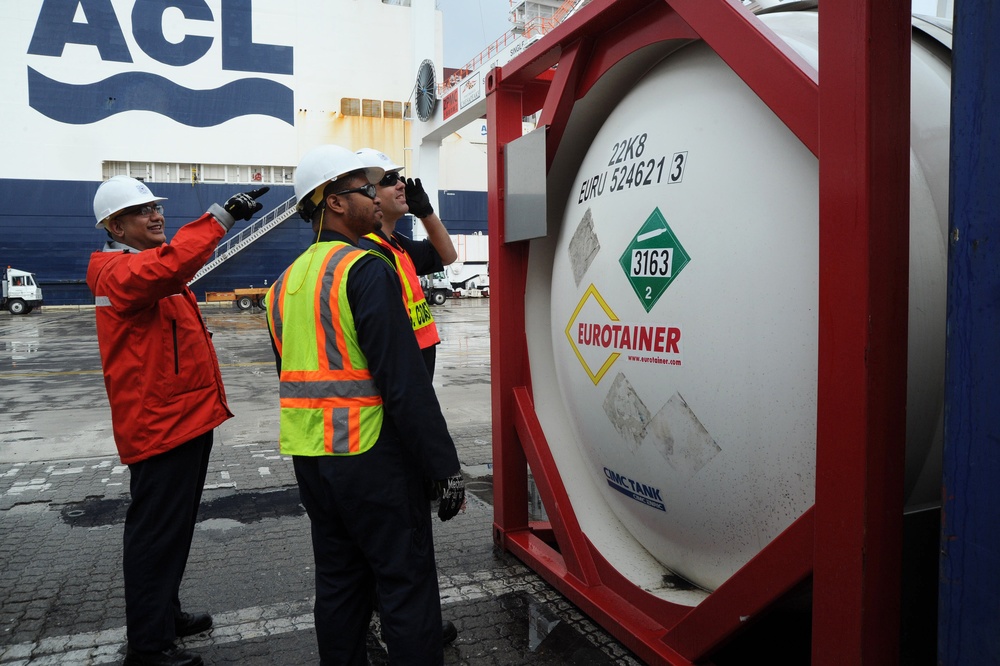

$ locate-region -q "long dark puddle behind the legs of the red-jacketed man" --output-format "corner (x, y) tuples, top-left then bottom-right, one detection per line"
(60, 487), (305, 527)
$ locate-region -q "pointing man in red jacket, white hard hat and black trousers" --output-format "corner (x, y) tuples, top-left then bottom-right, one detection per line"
(87, 176), (268, 666)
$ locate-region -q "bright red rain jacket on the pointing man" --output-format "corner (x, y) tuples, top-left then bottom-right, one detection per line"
(87, 213), (233, 465)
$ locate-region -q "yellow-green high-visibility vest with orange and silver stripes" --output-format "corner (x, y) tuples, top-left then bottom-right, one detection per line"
(265, 241), (383, 456)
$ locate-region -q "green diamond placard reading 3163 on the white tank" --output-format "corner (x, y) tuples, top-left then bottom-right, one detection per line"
(618, 208), (691, 312)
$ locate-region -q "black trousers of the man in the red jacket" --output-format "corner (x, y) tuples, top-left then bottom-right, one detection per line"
(122, 430), (212, 652)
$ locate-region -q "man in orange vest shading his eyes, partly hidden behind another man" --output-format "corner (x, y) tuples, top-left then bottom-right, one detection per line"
(358, 148), (458, 379)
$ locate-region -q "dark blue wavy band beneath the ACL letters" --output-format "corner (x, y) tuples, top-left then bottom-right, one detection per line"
(28, 67), (294, 127)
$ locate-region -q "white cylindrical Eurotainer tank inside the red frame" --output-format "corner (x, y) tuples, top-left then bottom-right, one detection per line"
(526, 12), (950, 592)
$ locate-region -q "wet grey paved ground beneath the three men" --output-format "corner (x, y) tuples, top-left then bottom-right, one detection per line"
(0, 299), (640, 666)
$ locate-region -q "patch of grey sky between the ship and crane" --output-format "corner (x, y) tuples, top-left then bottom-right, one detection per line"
(437, 0), (511, 68)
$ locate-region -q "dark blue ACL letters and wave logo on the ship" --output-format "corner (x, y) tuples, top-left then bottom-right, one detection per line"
(28, 0), (294, 127)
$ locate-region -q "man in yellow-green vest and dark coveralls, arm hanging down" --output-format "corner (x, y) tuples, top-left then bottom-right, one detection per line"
(265, 145), (465, 666)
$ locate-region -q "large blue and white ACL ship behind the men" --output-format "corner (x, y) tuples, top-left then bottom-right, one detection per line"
(0, 0), (485, 303)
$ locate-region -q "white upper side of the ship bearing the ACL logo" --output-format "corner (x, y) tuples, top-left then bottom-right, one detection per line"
(6, 0), (441, 182)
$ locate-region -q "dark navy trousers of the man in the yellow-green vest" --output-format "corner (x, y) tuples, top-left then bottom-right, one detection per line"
(293, 441), (444, 666)
